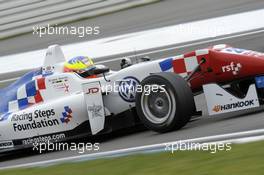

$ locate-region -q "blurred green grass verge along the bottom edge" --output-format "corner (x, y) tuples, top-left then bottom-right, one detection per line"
(0, 142), (264, 175)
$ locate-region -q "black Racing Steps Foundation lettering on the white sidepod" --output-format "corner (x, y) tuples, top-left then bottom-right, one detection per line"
(11, 109), (60, 132)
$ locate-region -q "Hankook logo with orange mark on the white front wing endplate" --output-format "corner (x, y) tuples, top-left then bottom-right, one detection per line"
(212, 100), (255, 112)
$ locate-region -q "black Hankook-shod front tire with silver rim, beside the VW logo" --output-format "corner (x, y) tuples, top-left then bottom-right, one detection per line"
(136, 72), (195, 133)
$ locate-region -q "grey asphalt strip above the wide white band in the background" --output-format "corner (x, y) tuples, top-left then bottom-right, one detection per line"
(0, 0), (264, 56)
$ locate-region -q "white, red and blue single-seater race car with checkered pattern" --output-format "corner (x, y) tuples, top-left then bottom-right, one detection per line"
(0, 44), (264, 150)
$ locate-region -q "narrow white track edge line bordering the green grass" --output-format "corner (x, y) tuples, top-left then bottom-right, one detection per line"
(0, 129), (264, 170)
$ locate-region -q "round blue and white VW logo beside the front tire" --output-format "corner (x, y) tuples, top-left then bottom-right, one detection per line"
(118, 76), (139, 102)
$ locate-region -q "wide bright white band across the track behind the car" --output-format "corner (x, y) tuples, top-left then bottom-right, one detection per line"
(0, 9), (264, 73)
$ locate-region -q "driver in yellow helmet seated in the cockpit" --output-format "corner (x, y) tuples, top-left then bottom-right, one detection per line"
(64, 56), (96, 78)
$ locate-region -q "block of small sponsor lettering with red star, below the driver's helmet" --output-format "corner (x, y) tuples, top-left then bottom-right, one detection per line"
(49, 77), (70, 93)
